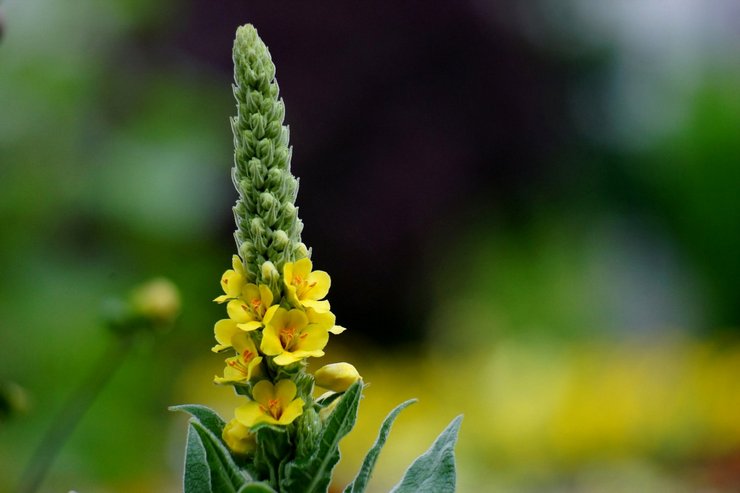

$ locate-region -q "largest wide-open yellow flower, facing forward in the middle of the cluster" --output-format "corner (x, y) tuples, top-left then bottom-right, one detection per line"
(260, 308), (333, 365)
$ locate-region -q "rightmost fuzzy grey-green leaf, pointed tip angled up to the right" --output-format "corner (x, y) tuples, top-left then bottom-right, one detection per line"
(391, 416), (462, 493)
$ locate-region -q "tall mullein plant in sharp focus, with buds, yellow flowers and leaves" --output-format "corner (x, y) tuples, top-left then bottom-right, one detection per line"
(172, 25), (461, 493)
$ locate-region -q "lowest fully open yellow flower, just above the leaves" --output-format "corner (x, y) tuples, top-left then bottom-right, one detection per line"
(235, 380), (304, 428)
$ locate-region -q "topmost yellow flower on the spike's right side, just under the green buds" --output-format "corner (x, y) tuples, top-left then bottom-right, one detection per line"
(283, 258), (331, 312)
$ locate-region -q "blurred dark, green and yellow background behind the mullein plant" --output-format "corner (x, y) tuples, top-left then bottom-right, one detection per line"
(0, 0), (740, 492)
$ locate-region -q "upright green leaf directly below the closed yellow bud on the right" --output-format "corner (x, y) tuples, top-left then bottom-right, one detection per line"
(280, 381), (363, 493)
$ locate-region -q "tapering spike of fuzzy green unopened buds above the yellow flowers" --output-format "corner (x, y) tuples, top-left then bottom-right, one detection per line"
(231, 25), (310, 291)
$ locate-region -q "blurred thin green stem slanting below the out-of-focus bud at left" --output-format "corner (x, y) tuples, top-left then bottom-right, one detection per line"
(18, 334), (135, 493)
